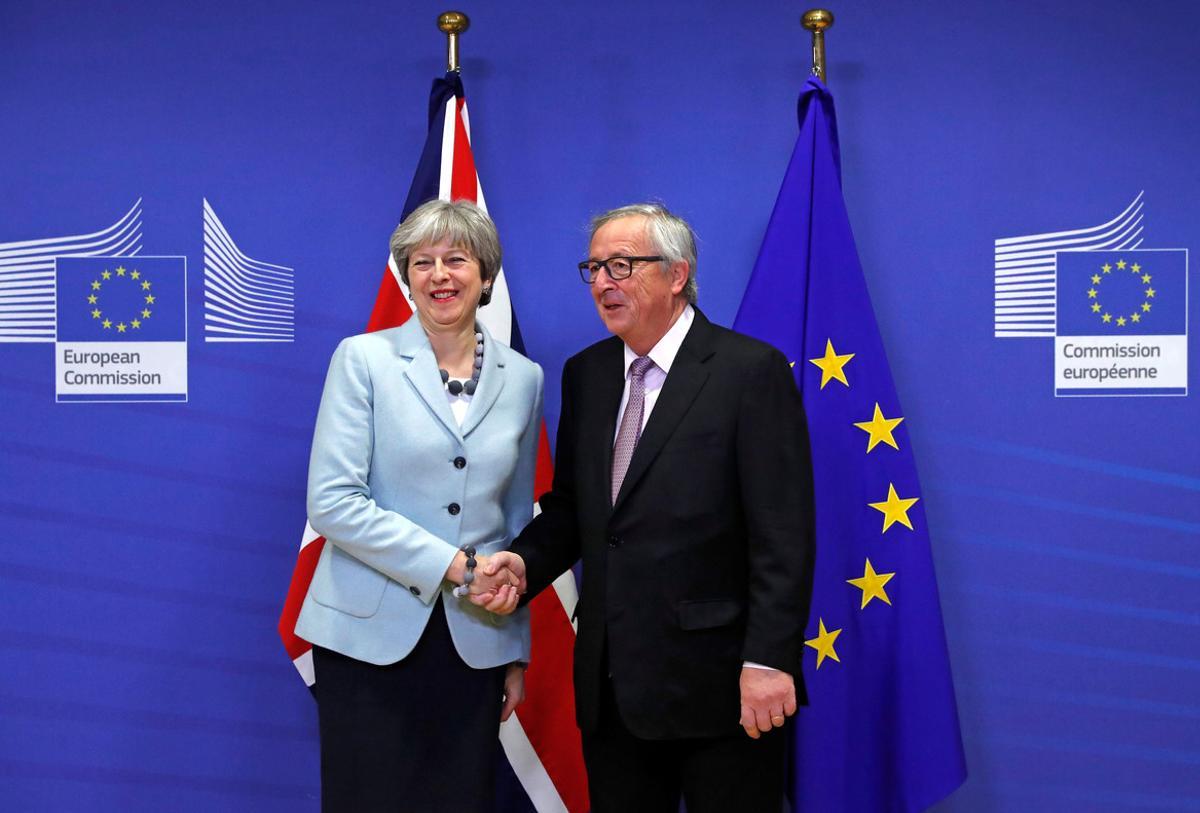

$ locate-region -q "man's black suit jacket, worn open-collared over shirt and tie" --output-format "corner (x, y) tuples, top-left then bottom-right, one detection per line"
(512, 311), (812, 740)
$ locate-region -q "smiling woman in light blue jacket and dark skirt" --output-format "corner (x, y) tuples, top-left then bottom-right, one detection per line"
(296, 200), (542, 812)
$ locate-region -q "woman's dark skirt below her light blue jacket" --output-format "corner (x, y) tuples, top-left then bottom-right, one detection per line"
(313, 600), (505, 813)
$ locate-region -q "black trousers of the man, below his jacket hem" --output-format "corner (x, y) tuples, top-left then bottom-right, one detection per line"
(583, 681), (792, 813)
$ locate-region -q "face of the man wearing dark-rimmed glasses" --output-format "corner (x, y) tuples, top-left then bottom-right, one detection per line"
(588, 215), (688, 355)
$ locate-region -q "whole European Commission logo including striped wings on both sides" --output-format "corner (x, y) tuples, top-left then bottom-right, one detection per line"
(0, 198), (295, 402)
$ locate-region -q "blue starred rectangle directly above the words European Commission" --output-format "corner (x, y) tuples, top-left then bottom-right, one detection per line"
(55, 257), (187, 342)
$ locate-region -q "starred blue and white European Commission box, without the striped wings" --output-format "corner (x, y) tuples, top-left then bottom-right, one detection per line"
(54, 257), (187, 402)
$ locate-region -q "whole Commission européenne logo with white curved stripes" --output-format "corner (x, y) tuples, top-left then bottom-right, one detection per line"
(995, 194), (1188, 397)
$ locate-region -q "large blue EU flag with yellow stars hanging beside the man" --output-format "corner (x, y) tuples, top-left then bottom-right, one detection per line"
(734, 78), (966, 812)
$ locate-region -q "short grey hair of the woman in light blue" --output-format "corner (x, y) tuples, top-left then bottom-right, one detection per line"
(388, 199), (500, 306)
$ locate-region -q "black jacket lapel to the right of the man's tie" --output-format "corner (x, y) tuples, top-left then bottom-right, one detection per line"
(608, 308), (713, 511)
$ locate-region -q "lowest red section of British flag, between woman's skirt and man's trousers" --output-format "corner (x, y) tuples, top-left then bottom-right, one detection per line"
(517, 589), (590, 813)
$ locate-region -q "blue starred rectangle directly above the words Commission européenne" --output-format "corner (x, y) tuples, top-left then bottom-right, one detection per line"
(1055, 248), (1188, 336)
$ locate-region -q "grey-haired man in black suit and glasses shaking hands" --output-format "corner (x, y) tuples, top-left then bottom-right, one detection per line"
(472, 205), (812, 813)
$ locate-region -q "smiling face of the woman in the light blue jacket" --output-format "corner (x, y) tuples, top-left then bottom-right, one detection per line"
(408, 240), (484, 333)
